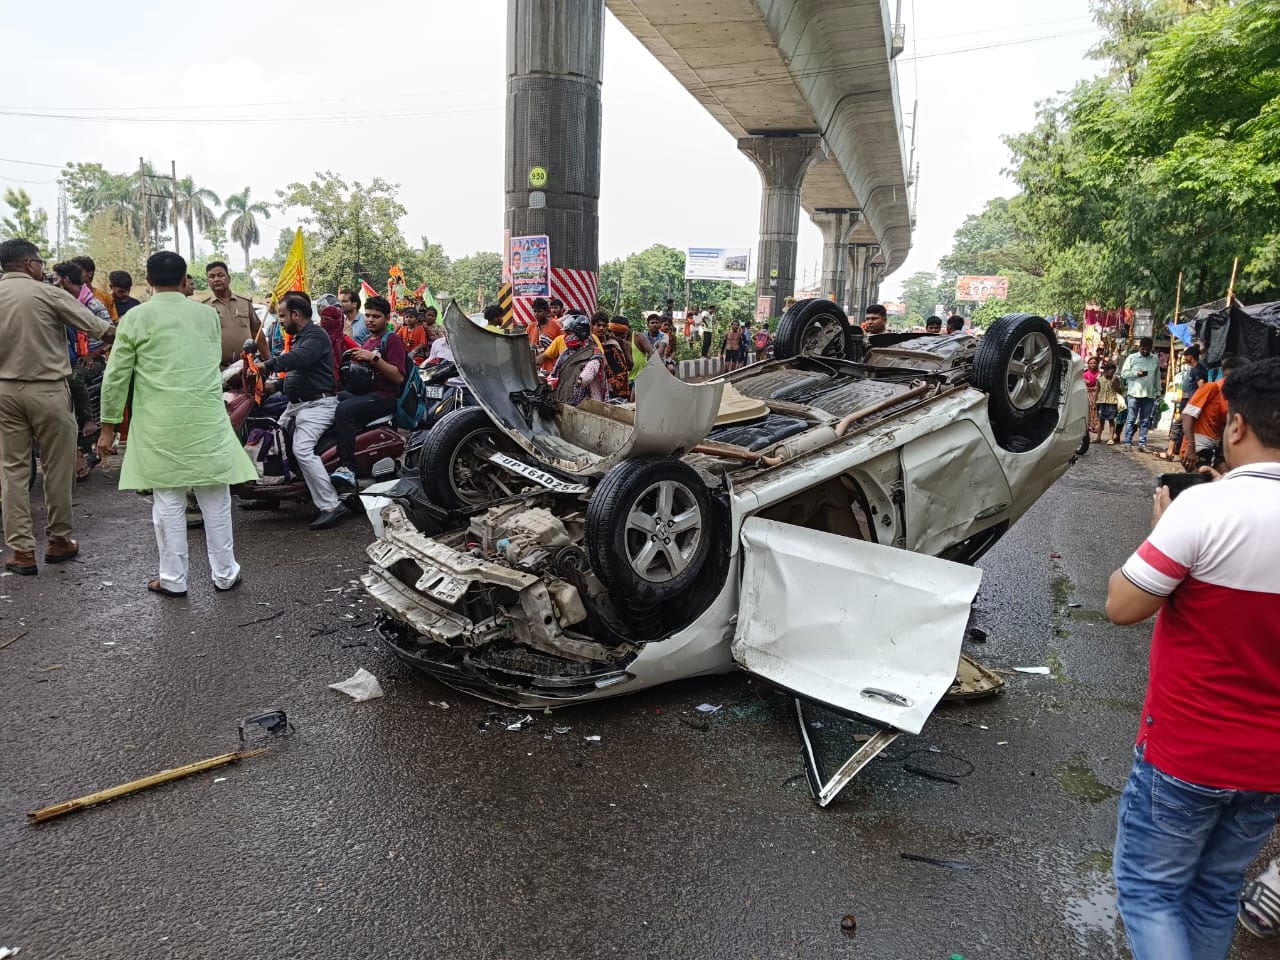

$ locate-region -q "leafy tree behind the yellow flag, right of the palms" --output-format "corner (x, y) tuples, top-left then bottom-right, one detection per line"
(276, 170), (409, 291)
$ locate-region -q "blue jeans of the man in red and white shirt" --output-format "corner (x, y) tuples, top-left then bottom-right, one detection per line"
(1112, 748), (1280, 960)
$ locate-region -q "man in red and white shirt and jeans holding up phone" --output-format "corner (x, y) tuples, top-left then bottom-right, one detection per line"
(1107, 358), (1280, 960)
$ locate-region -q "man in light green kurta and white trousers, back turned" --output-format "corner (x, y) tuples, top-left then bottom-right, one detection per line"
(97, 252), (257, 596)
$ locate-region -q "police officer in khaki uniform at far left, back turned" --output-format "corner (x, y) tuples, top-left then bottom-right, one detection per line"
(0, 239), (115, 576)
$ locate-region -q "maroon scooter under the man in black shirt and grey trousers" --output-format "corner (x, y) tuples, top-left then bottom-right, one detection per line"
(223, 340), (404, 508)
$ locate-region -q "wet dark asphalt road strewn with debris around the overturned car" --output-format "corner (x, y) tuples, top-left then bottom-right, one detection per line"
(0, 447), (1270, 960)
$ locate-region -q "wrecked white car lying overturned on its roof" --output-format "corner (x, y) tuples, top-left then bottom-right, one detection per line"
(364, 301), (1087, 790)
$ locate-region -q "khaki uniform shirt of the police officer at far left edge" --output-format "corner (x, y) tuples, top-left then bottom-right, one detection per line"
(0, 271), (111, 381)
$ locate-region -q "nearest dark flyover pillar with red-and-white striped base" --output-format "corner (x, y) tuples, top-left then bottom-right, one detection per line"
(506, 0), (604, 312)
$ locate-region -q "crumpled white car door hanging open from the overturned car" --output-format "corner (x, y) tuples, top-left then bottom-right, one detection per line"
(732, 517), (982, 745)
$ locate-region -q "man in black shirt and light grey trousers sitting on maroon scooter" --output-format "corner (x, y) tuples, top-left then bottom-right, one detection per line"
(262, 293), (348, 530)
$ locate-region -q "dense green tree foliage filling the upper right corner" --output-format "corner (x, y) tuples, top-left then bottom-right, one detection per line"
(940, 0), (1280, 316)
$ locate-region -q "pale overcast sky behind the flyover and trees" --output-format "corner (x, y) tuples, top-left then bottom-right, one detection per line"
(0, 0), (1098, 298)
